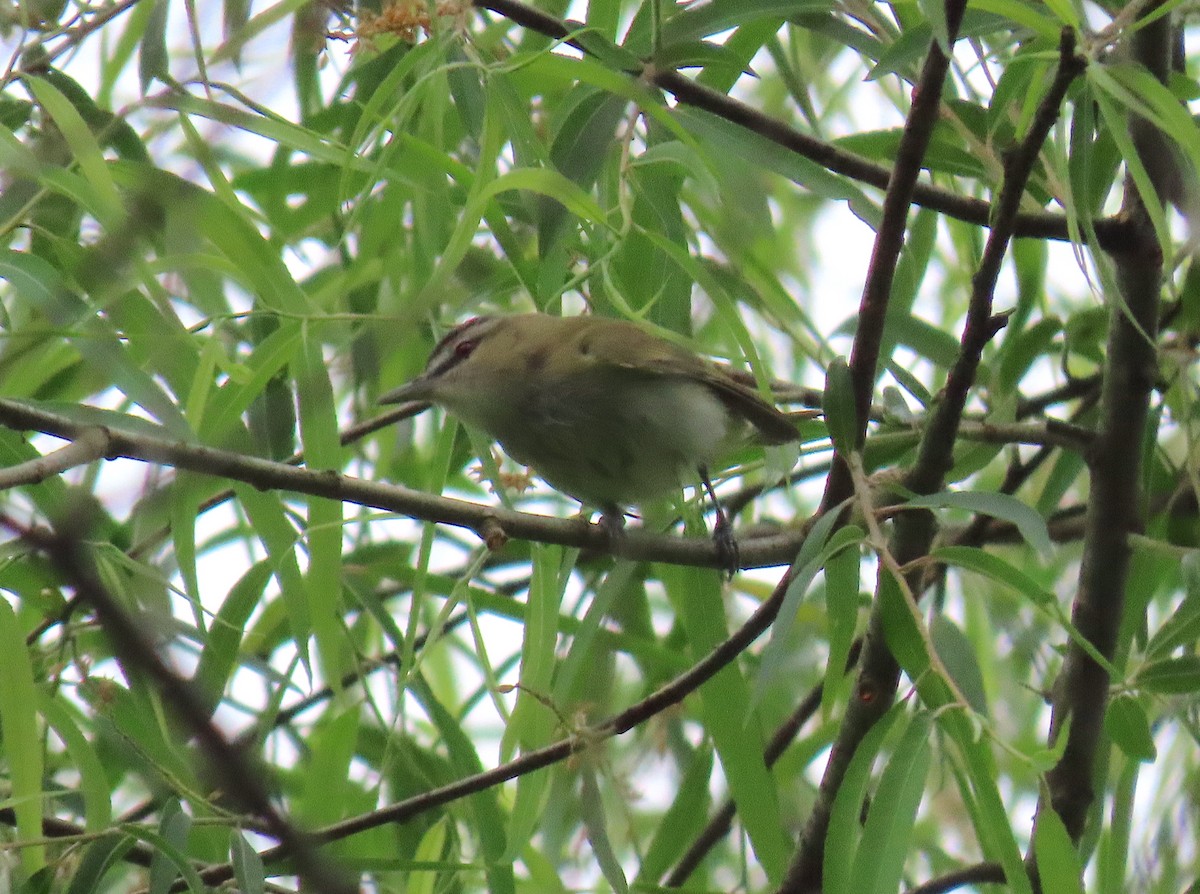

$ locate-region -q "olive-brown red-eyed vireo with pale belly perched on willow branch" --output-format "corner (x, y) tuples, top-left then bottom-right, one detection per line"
(380, 313), (798, 569)
